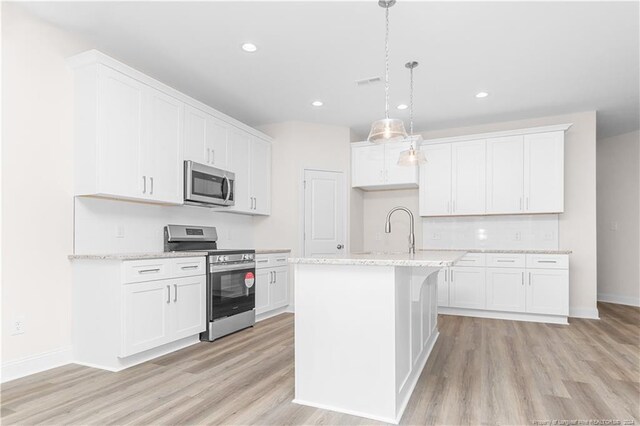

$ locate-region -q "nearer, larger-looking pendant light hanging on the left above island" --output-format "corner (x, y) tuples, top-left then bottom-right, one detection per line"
(367, 0), (407, 143)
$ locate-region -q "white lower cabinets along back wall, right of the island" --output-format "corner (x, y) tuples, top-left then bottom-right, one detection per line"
(438, 253), (569, 323)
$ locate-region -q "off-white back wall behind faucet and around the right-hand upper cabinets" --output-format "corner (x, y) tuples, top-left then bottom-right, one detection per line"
(363, 111), (596, 317)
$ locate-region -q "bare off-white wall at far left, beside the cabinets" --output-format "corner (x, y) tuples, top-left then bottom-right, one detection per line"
(2, 2), (90, 371)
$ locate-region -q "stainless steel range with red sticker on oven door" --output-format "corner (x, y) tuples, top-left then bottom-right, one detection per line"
(164, 225), (256, 342)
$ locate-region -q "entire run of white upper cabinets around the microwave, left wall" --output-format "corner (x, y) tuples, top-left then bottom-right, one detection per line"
(68, 50), (271, 214)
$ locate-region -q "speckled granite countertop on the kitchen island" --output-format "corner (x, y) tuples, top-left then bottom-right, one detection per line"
(289, 250), (467, 267)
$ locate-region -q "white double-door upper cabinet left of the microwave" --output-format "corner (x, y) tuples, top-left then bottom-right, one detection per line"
(74, 64), (184, 204)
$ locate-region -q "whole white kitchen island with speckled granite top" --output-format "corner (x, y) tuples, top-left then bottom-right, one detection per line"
(289, 251), (465, 423)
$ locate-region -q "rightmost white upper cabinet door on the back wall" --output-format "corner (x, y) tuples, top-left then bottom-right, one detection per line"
(524, 132), (564, 213)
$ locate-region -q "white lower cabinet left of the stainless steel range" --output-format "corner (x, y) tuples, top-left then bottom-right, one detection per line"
(73, 256), (206, 371)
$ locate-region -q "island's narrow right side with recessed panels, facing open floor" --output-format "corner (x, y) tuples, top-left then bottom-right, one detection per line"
(395, 267), (439, 422)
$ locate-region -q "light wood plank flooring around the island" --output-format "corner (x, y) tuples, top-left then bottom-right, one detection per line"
(1, 303), (640, 425)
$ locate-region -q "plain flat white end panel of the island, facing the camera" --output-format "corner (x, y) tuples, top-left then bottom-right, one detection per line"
(294, 264), (396, 422)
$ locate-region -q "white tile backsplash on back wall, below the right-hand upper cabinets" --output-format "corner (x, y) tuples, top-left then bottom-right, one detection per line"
(422, 214), (559, 250)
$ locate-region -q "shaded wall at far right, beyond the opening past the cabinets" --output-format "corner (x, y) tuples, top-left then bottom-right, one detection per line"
(597, 131), (640, 306)
